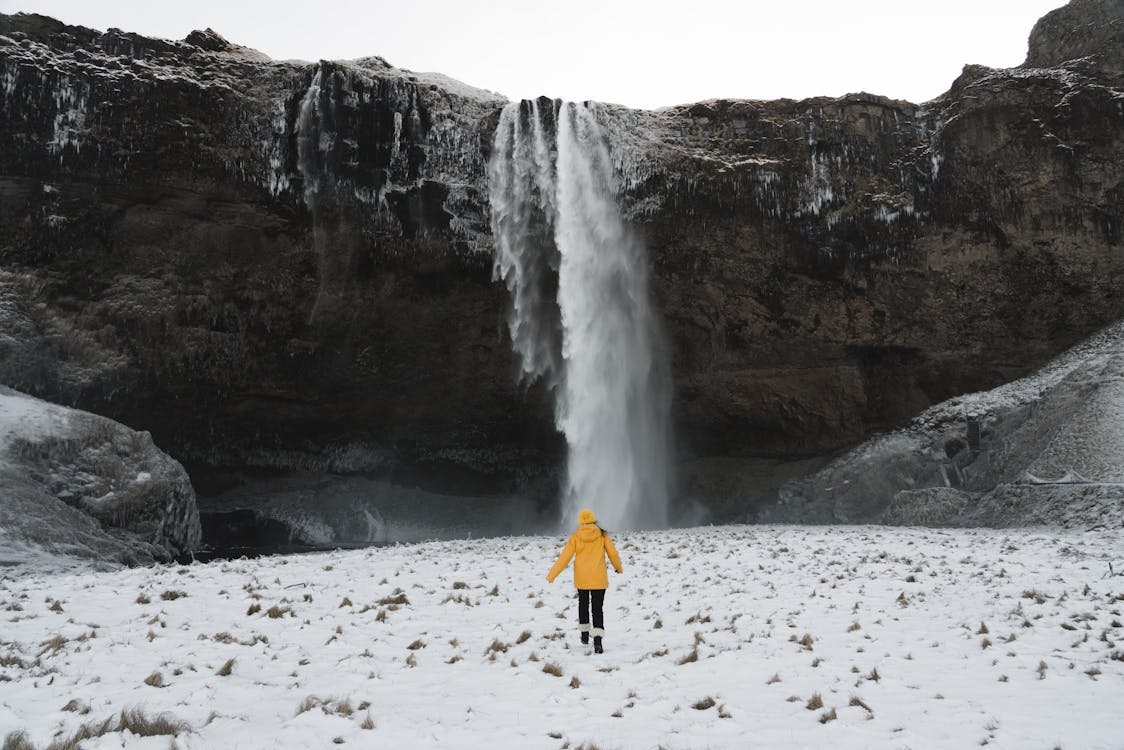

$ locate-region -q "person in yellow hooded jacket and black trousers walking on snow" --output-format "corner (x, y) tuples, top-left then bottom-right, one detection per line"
(546, 508), (624, 653)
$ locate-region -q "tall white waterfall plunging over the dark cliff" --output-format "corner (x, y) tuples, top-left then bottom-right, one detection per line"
(489, 100), (670, 528)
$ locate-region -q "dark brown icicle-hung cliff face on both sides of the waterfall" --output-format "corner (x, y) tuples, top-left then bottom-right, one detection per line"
(0, 0), (1124, 508)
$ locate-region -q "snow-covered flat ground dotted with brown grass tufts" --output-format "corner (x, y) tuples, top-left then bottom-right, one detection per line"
(0, 526), (1124, 750)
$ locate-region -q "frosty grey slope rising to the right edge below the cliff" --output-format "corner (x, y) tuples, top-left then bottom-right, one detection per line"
(758, 322), (1124, 527)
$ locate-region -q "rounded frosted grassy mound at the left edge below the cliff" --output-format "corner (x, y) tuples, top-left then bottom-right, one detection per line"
(0, 387), (201, 564)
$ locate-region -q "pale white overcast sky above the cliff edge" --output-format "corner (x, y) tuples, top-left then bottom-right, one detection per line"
(0, 0), (1064, 108)
